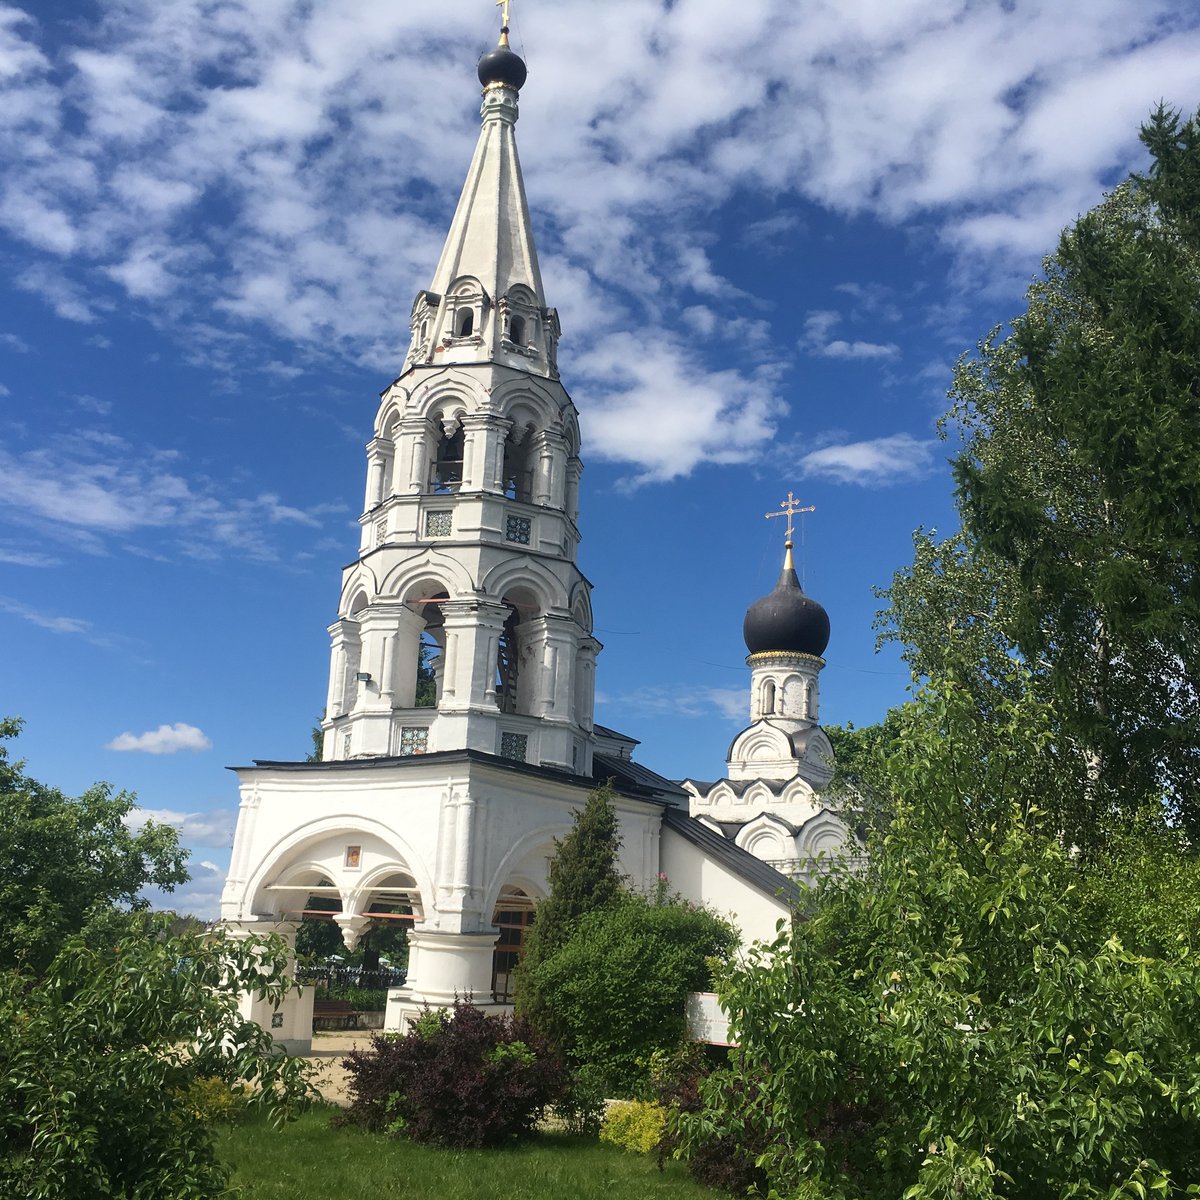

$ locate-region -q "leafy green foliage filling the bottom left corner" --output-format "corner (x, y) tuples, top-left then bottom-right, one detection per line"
(0, 914), (314, 1200)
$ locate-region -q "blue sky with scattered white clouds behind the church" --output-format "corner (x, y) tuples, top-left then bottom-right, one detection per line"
(0, 0), (1200, 916)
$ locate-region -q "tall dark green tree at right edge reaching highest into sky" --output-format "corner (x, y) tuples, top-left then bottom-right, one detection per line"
(884, 108), (1200, 853)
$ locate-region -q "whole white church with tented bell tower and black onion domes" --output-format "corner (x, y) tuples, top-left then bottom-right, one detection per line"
(221, 11), (852, 1051)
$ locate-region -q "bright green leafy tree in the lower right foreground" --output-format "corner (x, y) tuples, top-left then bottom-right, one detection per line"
(678, 683), (1200, 1200)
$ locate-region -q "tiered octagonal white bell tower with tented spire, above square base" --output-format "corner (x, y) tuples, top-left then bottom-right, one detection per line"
(323, 25), (600, 775)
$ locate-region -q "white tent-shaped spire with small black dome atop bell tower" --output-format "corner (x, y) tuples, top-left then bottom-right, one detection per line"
(430, 34), (546, 307)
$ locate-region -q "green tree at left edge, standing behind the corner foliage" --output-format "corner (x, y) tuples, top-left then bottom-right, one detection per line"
(0, 719), (187, 973)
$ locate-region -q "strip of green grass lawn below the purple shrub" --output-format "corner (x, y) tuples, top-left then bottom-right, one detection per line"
(217, 1109), (720, 1200)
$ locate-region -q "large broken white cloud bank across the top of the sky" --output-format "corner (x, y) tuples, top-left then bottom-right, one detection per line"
(0, 0), (1200, 480)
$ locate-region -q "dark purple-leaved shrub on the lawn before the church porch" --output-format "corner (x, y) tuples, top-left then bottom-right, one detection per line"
(343, 1001), (565, 1147)
